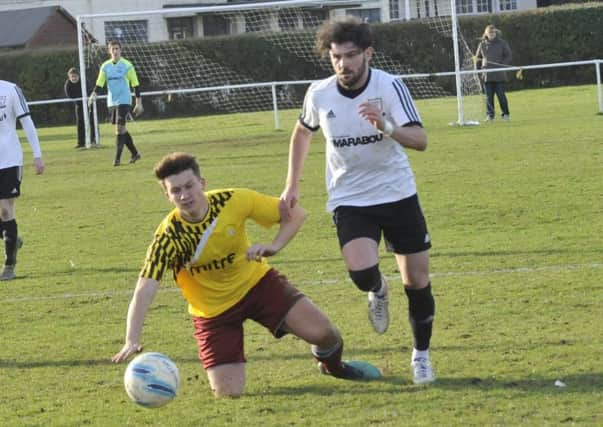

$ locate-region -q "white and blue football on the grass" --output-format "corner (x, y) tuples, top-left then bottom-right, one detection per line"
(124, 353), (180, 408)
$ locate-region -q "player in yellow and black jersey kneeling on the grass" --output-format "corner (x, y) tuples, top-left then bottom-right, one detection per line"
(112, 153), (380, 397)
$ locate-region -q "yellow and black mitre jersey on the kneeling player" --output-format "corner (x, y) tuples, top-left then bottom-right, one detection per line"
(140, 188), (280, 317)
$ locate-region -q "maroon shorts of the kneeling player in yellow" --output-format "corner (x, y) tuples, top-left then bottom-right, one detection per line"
(193, 269), (304, 369)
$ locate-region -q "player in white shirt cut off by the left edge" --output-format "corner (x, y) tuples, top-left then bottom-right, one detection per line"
(0, 80), (44, 280)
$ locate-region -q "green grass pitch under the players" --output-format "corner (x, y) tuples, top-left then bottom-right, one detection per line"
(0, 86), (603, 427)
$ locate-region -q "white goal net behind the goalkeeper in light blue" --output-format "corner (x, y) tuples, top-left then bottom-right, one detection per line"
(78, 0), (479, 145)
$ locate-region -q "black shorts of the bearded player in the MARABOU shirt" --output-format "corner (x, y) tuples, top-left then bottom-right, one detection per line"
(333, 194), (431, 255)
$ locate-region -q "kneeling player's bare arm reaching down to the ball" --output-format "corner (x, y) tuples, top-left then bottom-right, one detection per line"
(111, 277), (159, 363)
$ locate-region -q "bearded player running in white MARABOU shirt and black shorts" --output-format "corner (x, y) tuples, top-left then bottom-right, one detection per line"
(281, 18), (435, 384)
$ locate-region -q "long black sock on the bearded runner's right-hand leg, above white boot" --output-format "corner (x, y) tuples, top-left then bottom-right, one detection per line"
(404, 283), (435, 351)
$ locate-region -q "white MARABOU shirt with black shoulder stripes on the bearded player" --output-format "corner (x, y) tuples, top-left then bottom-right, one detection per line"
(299, 68), (421, 211)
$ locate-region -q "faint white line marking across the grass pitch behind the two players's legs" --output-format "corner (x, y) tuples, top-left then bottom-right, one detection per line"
(0, 263), (603, 304)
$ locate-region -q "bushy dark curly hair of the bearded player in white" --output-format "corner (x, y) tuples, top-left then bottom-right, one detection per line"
(316, 17), (373, 56)
